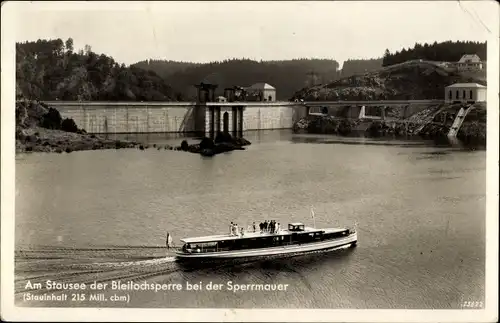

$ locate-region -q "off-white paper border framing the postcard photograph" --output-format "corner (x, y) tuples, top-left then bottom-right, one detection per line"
(1, 1), (499, 322)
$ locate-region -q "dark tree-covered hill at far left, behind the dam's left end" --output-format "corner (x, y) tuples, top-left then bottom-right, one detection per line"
(16, 38), (182, 101)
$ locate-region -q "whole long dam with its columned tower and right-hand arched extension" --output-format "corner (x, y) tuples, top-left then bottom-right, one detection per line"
(45, 100), (444, 136)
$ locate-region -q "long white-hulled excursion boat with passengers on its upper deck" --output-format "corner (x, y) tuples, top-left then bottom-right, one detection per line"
(176, 223), (358, 262)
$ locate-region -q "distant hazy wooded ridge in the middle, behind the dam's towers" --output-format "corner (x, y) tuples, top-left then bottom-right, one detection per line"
(133, 59), (340, 100)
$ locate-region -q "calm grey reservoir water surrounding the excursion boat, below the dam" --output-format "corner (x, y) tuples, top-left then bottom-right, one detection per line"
(15, 131), (486, 309)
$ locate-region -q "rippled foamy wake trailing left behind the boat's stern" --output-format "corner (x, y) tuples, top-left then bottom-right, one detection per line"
(15, 247), (180, 294)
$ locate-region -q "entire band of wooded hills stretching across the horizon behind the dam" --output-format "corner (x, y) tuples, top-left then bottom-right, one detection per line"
(16, 38), (486, 101)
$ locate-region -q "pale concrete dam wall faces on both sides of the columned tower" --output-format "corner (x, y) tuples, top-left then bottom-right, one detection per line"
(45, 101), (306, 133)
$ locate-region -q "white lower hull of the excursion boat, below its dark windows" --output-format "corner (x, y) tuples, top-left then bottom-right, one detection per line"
(176, 233), (358, 262)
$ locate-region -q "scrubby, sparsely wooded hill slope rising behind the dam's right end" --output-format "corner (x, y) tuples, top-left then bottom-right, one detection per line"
(292, 60), (486, 101)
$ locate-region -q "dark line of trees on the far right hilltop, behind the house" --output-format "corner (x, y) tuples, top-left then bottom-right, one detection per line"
(382, 41), (486, 66)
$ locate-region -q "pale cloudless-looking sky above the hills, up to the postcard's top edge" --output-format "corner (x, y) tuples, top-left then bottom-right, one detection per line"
(8, 1), (499, 64)
